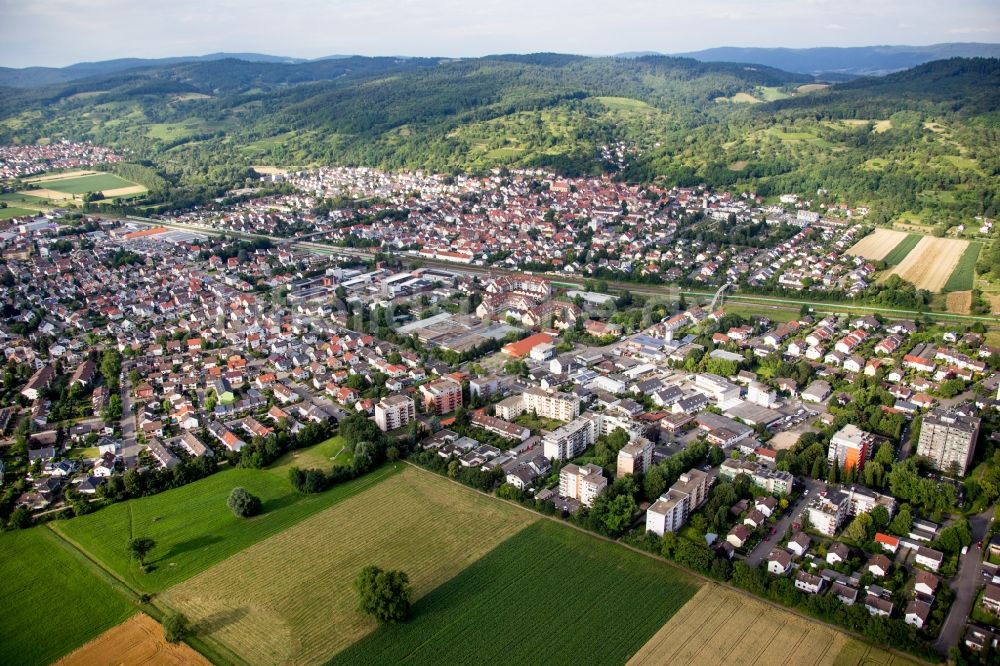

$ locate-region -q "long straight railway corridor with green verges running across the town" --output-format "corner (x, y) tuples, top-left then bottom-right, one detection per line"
(126, 216), (1000, 324)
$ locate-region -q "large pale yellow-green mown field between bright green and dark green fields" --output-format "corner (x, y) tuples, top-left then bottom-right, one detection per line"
(160, 465), (540, 664)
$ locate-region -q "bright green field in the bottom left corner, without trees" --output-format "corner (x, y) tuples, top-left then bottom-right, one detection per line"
(0, 527), (135, 664)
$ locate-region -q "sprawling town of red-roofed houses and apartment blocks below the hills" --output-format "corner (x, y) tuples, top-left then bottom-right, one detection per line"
(0, 165), (1000, 655)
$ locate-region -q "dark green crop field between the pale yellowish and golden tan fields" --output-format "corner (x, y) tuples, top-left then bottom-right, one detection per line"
(332, 520), (699, 664)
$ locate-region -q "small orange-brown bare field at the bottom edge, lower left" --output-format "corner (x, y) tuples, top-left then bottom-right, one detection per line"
(56, 613), (210, 666)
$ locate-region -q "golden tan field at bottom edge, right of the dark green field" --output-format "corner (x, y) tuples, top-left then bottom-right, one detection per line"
(628, 584), (913, 666)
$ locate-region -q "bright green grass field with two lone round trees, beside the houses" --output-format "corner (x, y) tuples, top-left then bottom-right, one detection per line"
(55, 467), (396, 592)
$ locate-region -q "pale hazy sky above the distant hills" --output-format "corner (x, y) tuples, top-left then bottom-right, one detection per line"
(0, 0), (1000, 67)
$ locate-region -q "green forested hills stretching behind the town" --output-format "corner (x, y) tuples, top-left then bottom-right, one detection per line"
(0, 53), (1000, 217)
